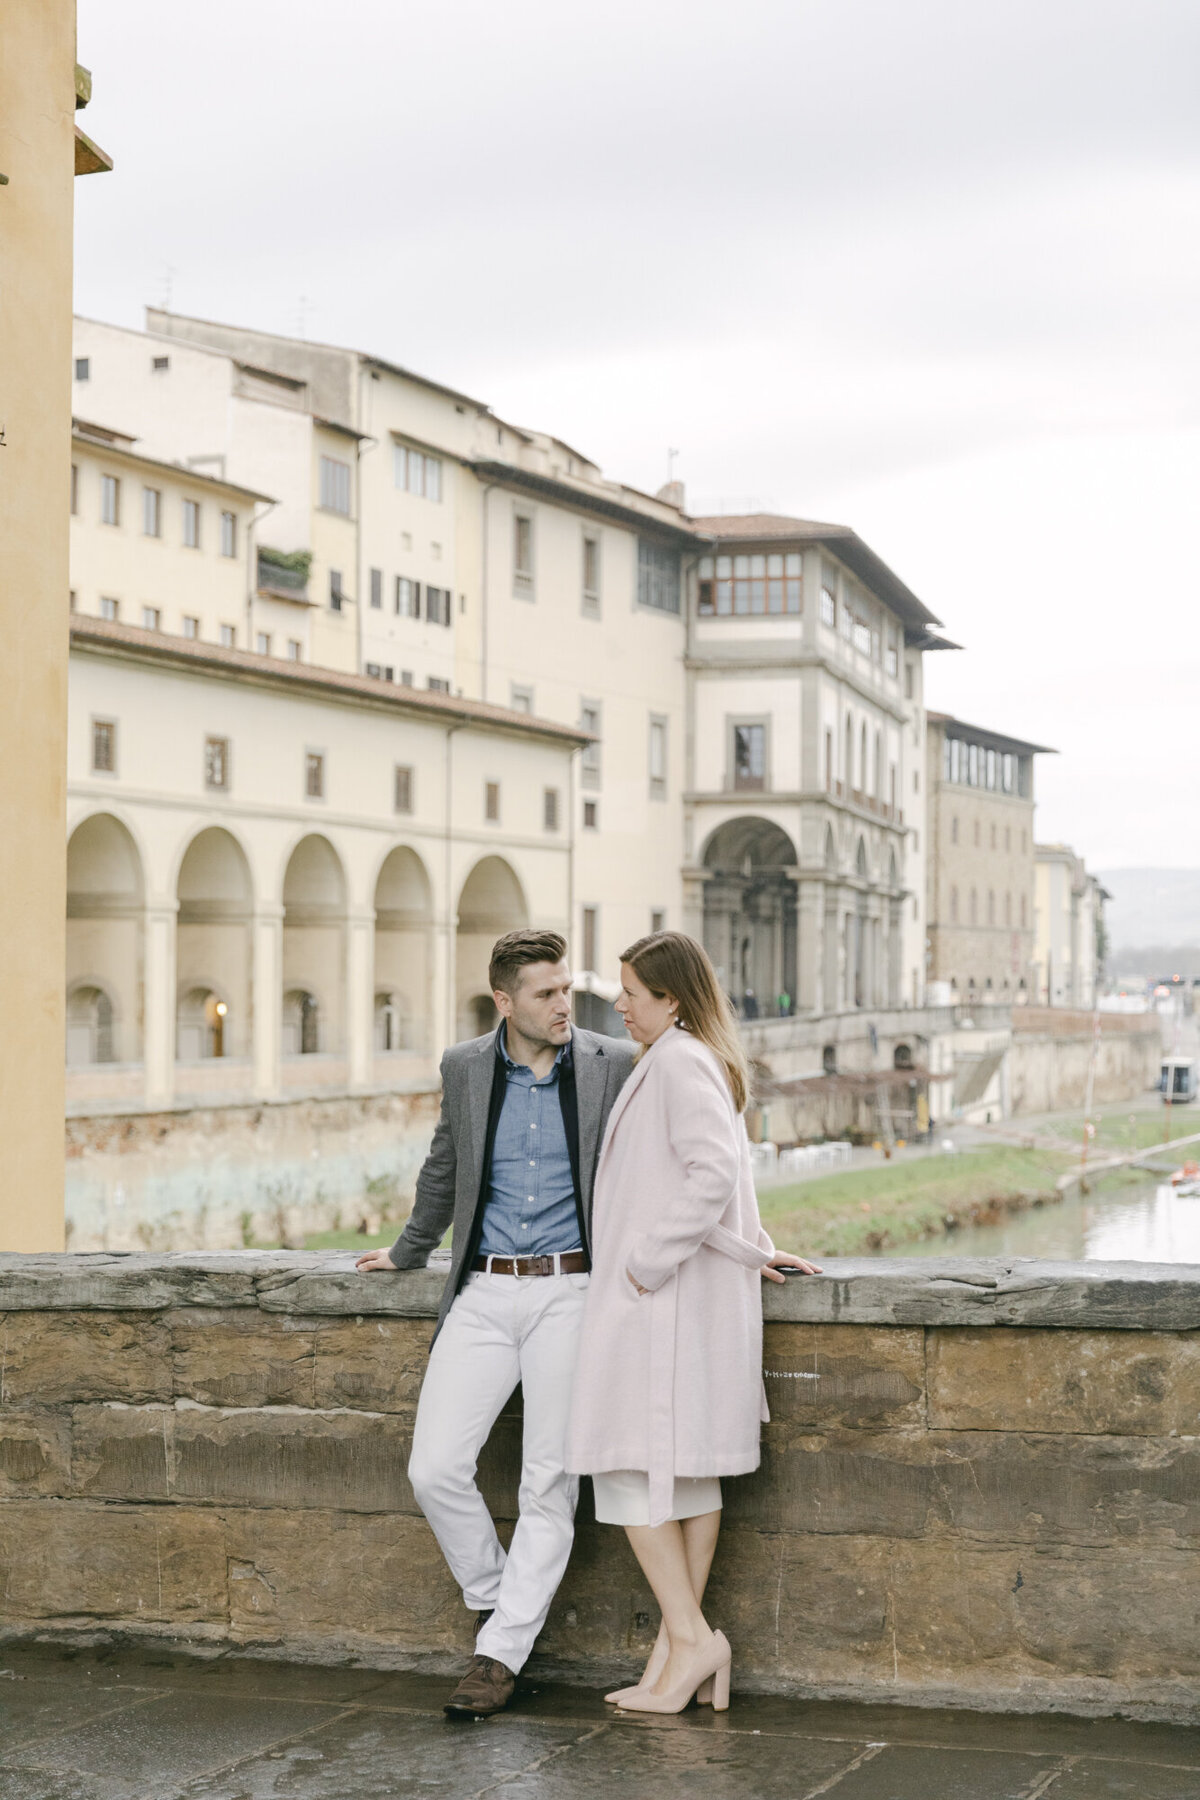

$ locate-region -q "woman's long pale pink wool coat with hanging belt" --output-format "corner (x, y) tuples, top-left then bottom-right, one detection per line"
(567, 1028), (774, 1525)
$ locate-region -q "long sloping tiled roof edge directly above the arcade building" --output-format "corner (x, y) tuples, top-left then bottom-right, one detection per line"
(70, 614), (592, 751)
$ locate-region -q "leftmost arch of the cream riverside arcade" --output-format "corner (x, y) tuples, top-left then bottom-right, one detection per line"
(67, 812), (146, 1064)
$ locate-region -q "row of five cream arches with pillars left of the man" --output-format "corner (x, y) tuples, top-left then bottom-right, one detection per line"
(67, 812), (531, 1105)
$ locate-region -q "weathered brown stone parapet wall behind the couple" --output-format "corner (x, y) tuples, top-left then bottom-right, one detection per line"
(0, 1253), (1200, 1719)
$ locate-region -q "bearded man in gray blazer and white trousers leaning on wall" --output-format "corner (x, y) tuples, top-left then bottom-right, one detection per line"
(358, 931), (635, 1717)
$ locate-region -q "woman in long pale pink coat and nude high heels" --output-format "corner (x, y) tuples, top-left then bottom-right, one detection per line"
(569, 931), (820, 1712)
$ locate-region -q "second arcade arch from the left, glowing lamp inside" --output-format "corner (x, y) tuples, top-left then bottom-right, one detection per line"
(175, 824), (254, 1062)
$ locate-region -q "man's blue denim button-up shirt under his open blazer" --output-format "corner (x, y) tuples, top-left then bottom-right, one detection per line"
(479, 1022), (579, 1256)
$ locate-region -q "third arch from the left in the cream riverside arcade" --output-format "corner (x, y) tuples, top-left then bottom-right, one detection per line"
(282, 832), (345, 1057)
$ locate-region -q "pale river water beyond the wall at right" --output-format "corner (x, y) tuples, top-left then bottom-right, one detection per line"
(880, 1175), (1200, 1264)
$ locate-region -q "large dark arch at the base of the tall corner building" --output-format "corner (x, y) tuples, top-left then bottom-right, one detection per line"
(702, 815), (799, 1019)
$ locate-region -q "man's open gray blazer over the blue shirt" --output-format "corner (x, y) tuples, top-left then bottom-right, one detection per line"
(389, 1026), (635, 1336)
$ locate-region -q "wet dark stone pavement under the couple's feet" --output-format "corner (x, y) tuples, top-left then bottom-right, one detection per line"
(0, 1645), (1200, 1800)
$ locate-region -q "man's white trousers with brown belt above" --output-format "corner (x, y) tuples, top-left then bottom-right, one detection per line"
(408, 1273), (588, 1674)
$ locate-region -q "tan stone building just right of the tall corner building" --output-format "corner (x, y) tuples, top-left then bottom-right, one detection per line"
(927, 713), (1049, 1004)
